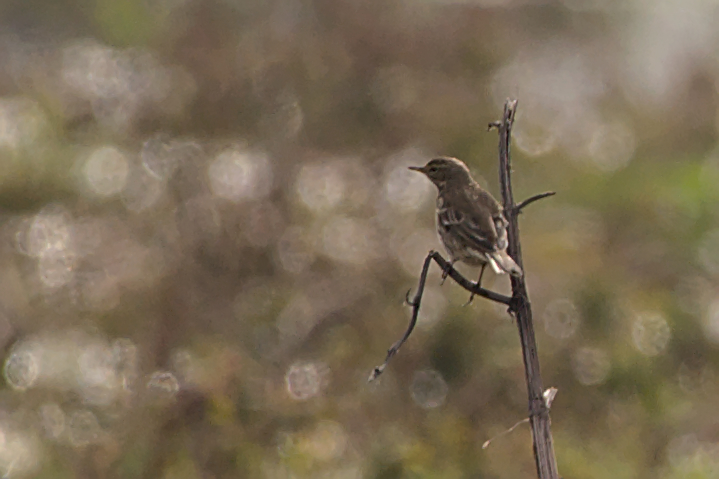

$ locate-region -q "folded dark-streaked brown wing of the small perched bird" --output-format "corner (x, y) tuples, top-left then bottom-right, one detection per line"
(437, 205), (498, 252)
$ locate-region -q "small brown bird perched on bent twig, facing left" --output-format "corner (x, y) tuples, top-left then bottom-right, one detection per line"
(409, 157), (523, 302)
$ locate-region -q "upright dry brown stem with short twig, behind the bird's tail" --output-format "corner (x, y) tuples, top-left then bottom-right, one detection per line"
(498, 100), (559, 479)
